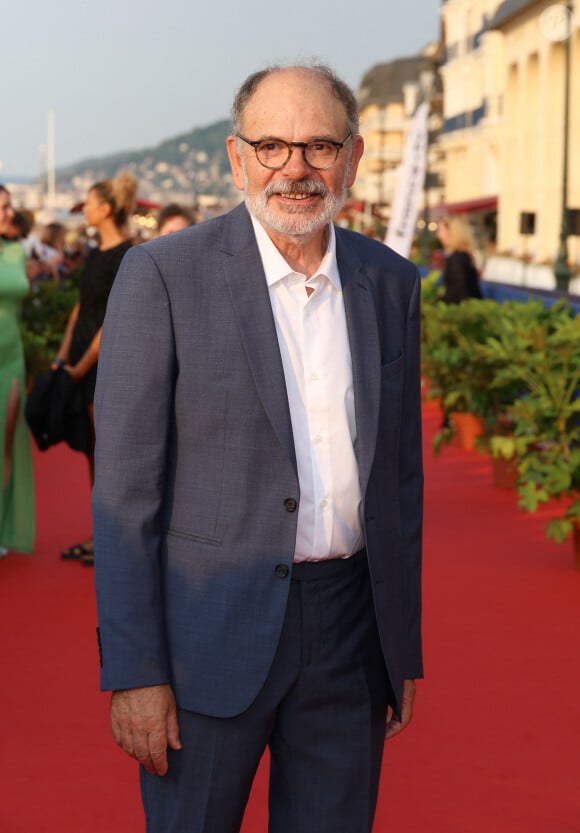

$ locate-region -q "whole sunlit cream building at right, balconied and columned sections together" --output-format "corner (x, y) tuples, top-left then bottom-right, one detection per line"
(439, 0), (580, 264)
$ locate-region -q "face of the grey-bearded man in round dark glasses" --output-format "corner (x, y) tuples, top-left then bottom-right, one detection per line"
(228, 69), (363, 238)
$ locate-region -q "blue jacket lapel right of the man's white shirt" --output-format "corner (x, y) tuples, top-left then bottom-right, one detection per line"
(336, 229), (381, 495)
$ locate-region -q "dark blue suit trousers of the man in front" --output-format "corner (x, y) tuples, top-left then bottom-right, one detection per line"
(141, 550), (392, 833)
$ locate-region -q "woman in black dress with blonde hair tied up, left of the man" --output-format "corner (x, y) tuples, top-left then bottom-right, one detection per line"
(56, 172), (137, 566)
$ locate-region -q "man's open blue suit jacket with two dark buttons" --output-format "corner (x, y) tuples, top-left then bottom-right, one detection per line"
(93, 206), (423, 716)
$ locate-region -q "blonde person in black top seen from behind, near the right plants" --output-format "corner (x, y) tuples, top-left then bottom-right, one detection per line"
(437, 216), (482, 304)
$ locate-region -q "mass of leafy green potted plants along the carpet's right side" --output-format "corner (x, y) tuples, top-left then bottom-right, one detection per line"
(423, 290), (580, 541)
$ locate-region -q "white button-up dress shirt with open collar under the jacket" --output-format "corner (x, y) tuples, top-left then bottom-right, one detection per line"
(252, 217), (364, 561)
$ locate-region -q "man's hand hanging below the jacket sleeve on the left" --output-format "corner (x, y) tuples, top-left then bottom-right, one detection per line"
(111, 685), (181, 775)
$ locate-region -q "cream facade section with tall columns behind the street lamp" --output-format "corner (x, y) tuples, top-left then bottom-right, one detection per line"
(492, 0), (580, 265)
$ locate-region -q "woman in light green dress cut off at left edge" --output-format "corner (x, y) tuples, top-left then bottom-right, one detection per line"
(0, 185), (34, 555)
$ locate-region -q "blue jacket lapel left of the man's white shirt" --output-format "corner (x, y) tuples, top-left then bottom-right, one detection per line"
(221, 205), (297, 471)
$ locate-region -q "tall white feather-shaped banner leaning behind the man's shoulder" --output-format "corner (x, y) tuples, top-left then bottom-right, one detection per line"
(385, 101), (429, 257)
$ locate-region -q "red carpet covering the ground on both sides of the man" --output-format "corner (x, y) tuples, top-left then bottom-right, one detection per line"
(0, 405), (580, 833)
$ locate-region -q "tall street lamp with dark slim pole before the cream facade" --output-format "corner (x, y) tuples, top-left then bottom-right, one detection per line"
(540, 0), (573, 292)
